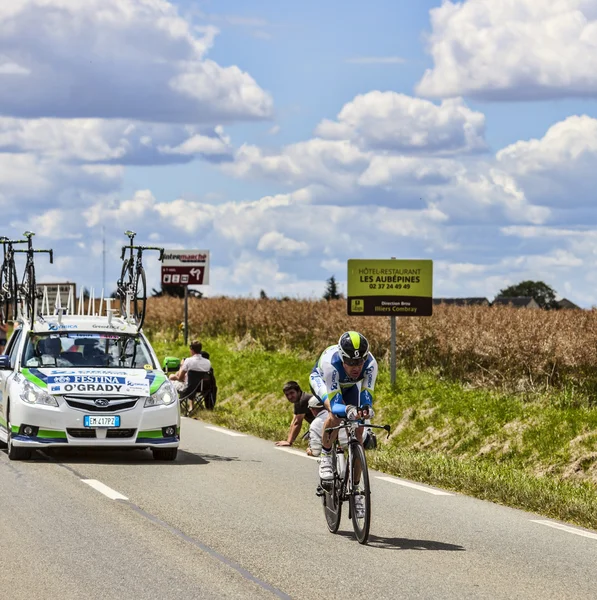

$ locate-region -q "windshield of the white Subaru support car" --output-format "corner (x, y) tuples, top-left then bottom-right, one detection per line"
(23, 331), (154, 369)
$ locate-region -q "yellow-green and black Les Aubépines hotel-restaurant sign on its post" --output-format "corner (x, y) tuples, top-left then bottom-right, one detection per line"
(347, 258), (433, 385)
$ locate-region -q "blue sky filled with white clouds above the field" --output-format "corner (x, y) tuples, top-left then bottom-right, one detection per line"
(0, 0), (597, 308)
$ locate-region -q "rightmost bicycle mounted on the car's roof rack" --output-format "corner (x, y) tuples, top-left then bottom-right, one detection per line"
(116, 231), (164, 329)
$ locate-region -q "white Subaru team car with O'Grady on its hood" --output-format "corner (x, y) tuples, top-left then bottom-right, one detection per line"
(0, 315), (180, 460)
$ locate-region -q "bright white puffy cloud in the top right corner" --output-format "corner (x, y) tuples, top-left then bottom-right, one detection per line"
(417, 0), (597, 100)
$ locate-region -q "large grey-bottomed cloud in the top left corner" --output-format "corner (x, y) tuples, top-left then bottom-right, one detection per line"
(0, 0), (272, 124)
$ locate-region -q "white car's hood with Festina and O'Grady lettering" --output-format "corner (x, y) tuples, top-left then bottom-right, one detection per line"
(21, 368), (166, 396)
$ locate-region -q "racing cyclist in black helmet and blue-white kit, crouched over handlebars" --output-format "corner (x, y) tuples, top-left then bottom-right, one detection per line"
(310, 331), (377, 488)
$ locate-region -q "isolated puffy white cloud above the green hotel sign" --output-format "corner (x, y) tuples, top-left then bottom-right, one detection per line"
(315, 91), (487, 154)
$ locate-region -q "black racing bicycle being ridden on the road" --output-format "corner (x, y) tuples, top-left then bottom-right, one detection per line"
(318, 419), (390, 544)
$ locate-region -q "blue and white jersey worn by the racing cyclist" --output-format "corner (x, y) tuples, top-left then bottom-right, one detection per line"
(309, 345), (377, 417)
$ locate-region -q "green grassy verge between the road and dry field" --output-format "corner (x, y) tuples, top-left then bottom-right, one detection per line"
(152, 337), (597, 529)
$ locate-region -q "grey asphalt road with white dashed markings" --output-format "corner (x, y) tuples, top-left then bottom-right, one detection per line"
(0, 419), (597, 600)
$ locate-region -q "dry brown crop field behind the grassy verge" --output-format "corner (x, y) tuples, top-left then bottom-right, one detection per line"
(145, 298), (597, 396)
